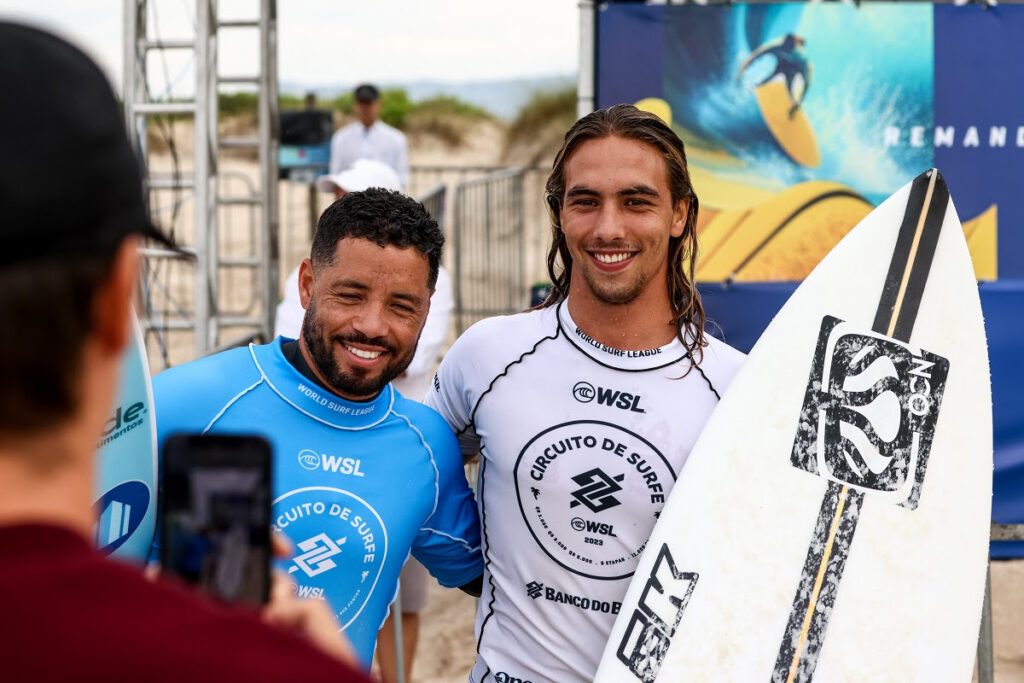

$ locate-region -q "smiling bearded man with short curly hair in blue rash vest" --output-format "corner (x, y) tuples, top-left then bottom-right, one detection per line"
(154, 188), (483, 668)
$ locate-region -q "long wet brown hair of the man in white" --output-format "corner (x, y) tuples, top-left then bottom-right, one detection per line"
(541, 104), (708, 364)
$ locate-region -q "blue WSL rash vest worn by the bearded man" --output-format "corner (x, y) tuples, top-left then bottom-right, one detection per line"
(153, 337), (483, 669)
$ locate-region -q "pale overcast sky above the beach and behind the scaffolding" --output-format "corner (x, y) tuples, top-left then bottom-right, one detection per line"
(0, 0), (579, 93)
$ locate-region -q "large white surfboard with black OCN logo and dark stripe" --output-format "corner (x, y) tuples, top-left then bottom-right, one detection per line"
(596, 169), (992, 683)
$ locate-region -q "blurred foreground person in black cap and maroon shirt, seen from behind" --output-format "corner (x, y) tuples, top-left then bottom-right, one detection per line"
(0, 22), (366, 681)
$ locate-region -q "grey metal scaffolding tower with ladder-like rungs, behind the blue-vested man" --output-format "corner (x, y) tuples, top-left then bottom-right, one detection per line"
(123, 0), (279, 366)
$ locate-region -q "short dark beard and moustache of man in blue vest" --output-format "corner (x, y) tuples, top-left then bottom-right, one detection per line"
(302, 299), (417, 399)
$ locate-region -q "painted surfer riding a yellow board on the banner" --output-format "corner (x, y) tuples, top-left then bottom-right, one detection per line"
(736, 33), (821, 168)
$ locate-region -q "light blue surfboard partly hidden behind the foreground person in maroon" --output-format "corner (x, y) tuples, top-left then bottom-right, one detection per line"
(95, 317), (157, 562)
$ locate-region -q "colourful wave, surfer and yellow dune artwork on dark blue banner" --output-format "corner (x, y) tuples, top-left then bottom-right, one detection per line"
(623, 3), (1003, 283)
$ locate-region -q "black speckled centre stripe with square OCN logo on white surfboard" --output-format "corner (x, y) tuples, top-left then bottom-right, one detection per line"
(772, 169), (955, 683)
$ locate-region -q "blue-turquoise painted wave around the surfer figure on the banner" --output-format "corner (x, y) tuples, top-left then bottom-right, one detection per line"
(663, 3), (933, 203)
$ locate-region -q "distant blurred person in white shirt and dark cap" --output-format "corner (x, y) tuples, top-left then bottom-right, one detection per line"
(330, 84), (409, 187)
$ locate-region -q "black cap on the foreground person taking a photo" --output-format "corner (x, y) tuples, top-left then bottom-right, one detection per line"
(0, 22), (173, 265)
